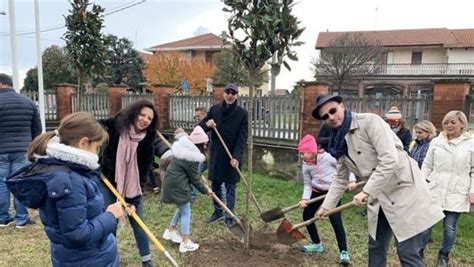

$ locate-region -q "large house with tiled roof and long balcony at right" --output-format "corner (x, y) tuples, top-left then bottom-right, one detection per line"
(315, 28), (474, 95)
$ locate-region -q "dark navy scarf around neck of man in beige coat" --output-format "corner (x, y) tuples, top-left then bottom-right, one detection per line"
(328, 109), (352, 159)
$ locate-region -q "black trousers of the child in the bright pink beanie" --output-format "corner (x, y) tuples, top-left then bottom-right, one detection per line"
(303, 191), (347, 251)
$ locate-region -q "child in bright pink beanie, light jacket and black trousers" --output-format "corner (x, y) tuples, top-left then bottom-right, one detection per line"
(298, 135), (355, 264)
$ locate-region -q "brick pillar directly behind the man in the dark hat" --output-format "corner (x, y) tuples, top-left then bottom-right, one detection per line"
(300, 82), (329, 138)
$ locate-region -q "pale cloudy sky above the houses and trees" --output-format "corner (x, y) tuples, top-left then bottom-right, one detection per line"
(0, 0), (474, 90)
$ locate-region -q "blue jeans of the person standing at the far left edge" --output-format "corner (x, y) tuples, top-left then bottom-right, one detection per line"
(0, 153), (29, 225)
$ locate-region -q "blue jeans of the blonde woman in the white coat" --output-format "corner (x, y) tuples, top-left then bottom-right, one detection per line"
(422, 210), (461, 255)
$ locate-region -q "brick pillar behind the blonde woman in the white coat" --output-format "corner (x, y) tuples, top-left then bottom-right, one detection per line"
(431, 80), (471, 129)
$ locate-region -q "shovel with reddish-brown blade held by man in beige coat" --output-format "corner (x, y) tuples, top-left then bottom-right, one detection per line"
(277, 201), (355, 245)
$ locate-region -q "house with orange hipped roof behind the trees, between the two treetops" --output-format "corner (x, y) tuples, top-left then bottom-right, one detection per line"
(145, 33), (227, 64)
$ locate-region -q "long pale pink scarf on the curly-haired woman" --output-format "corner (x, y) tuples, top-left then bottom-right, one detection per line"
(115, 126), (146, 198)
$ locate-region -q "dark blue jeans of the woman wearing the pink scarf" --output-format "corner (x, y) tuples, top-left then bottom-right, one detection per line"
(97, 180), (151, 261)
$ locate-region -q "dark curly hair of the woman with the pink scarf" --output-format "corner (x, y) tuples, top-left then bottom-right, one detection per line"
(116, 99), (158, 134)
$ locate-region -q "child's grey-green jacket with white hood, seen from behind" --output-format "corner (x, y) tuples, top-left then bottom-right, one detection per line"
(161, 135), (208, 205)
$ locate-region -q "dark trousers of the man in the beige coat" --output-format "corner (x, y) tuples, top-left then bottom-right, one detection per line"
(369, 208), (425, 267)
